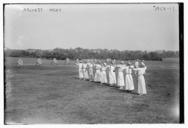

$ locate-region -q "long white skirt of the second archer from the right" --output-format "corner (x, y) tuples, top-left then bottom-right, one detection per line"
(125, 74), (134, 90)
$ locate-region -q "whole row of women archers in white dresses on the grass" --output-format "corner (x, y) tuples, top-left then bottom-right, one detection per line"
(77, 63), (147, 94)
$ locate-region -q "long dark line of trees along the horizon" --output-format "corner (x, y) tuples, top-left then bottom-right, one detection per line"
(4, 48), (179, 61)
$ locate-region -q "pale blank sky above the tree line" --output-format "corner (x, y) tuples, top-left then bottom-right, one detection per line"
(5, 4), (179, 51)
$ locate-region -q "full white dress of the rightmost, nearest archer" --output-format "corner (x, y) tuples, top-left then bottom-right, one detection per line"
(136, 67), (147, 94)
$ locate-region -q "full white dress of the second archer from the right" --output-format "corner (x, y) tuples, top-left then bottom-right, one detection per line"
(125, 67), (134, 90)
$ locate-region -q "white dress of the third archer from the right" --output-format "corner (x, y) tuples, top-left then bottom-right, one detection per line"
(117, 66), (125, 88)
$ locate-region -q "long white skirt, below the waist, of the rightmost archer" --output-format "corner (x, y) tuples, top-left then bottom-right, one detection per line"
(138, 75), (147, 94)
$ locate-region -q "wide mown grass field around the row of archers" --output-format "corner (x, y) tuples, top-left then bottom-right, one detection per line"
(5, 58), (179, 124)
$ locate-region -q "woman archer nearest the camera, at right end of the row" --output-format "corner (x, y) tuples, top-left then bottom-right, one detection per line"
(133, 62), (147, 95)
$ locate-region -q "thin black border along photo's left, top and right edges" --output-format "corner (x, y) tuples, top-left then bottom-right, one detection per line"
(0, 2), (185, 128)
